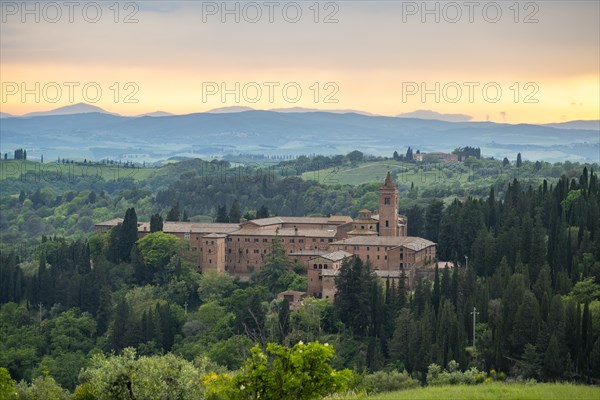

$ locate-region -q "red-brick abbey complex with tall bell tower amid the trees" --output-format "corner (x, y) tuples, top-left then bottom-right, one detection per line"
(96, 172), (452, 301)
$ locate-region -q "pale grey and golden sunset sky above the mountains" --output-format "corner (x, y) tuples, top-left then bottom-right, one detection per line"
(0, 0), (600, 123)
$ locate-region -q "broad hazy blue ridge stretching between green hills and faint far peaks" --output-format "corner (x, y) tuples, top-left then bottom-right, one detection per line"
(0, 110), (600, 162)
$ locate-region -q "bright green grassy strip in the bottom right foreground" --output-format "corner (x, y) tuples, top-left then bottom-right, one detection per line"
(350, 383), (600, 400)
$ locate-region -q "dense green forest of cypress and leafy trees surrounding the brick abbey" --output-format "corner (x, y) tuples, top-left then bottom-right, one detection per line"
(0, 155), (600, 398)
